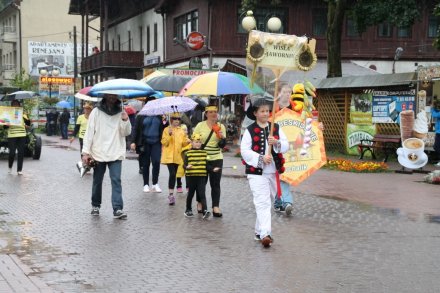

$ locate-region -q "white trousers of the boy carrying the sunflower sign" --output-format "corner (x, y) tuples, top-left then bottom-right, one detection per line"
(248, 173), (277, 239)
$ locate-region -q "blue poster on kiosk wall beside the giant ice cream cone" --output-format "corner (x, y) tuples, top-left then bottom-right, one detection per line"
(372, 89), (416, 124)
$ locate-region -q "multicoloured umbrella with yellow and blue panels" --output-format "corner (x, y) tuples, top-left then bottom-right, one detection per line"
(179, 71), (252, 96)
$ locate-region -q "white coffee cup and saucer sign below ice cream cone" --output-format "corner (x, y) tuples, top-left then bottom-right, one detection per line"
(397, 137), (428, 169)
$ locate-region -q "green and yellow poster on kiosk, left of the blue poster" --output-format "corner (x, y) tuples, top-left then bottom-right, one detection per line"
(350, 93), (373, 125)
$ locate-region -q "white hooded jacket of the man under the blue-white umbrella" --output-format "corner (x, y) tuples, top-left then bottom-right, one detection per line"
(82, 108), (131, 162)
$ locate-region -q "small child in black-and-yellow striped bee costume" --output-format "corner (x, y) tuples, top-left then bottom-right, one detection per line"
(183, 133), (216, 219)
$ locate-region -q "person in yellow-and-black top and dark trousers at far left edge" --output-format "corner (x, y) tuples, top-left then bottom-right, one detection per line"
(5, 100), (31, 175)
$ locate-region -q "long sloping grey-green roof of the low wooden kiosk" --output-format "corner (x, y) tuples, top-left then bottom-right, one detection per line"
(316, 72), (417, 89)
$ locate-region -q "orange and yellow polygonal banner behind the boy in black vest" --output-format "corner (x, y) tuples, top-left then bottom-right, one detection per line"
(275, 108), (327, 186)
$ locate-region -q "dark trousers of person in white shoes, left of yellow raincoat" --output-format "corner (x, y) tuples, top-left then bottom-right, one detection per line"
(140, 141), (162, 185)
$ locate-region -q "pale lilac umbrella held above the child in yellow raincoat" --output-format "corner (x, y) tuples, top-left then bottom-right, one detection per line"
(139, 96), (197, 116)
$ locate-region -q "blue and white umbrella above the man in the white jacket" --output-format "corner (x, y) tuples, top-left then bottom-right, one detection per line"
(88, 78), (154, 98)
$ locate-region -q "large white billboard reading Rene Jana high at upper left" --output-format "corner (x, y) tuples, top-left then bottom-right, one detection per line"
(28, 41), (93, 76)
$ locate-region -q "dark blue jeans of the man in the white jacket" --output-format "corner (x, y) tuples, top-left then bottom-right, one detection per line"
(92, 160), (124, 211)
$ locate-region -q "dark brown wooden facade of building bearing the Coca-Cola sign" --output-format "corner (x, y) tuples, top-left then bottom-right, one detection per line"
(163, 0), (440, 64)
